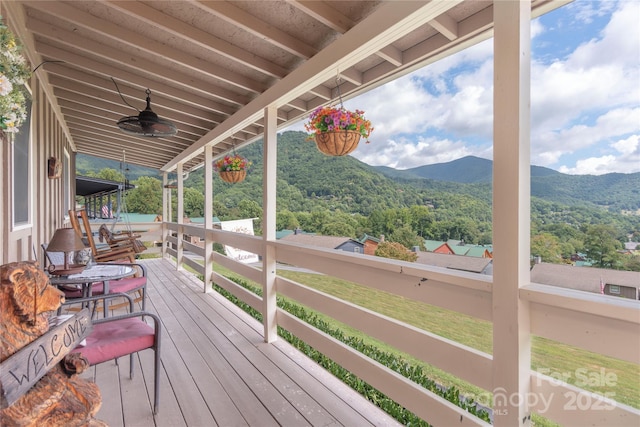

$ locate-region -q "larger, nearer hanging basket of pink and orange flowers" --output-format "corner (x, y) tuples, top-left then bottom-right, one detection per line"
(304, 106), (373, 156)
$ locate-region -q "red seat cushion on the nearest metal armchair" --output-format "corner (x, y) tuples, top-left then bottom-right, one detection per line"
(73, 317), (155, 365)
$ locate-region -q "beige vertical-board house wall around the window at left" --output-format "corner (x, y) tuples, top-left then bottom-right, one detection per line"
(0, 76), (75, 264)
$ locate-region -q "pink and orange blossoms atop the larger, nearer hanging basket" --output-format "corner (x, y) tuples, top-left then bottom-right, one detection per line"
(304, 107), (373, 143)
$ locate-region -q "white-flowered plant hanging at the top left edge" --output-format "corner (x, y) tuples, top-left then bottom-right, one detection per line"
(0, 17), (31, 137)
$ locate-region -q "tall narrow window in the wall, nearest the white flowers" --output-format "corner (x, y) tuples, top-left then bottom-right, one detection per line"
(12, 100), (31, 228)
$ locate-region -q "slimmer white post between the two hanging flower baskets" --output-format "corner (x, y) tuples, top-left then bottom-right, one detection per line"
(262, 105), (278, 342)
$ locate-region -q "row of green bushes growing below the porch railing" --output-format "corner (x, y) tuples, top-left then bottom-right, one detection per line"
(213, 277), (490, 427)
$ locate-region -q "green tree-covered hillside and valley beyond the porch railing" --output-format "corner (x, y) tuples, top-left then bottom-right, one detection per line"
(76, 132), (640, 270)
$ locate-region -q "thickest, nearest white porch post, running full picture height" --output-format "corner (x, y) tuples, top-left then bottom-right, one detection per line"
(493, 0), (531, 427)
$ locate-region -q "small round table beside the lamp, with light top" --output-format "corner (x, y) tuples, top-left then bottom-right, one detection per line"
(49, 264), (135, 317)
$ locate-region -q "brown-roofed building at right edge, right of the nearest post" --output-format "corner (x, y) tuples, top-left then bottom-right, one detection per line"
(531, 262), (640, 300)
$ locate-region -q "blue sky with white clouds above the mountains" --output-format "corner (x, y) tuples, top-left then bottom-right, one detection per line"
(292, 0), (640, 175)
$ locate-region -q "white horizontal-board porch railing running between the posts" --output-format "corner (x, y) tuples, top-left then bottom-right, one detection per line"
(163, 223), (640, 426)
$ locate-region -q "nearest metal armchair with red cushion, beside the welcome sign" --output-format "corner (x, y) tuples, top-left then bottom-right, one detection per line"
(63, 294), (161, 414)
